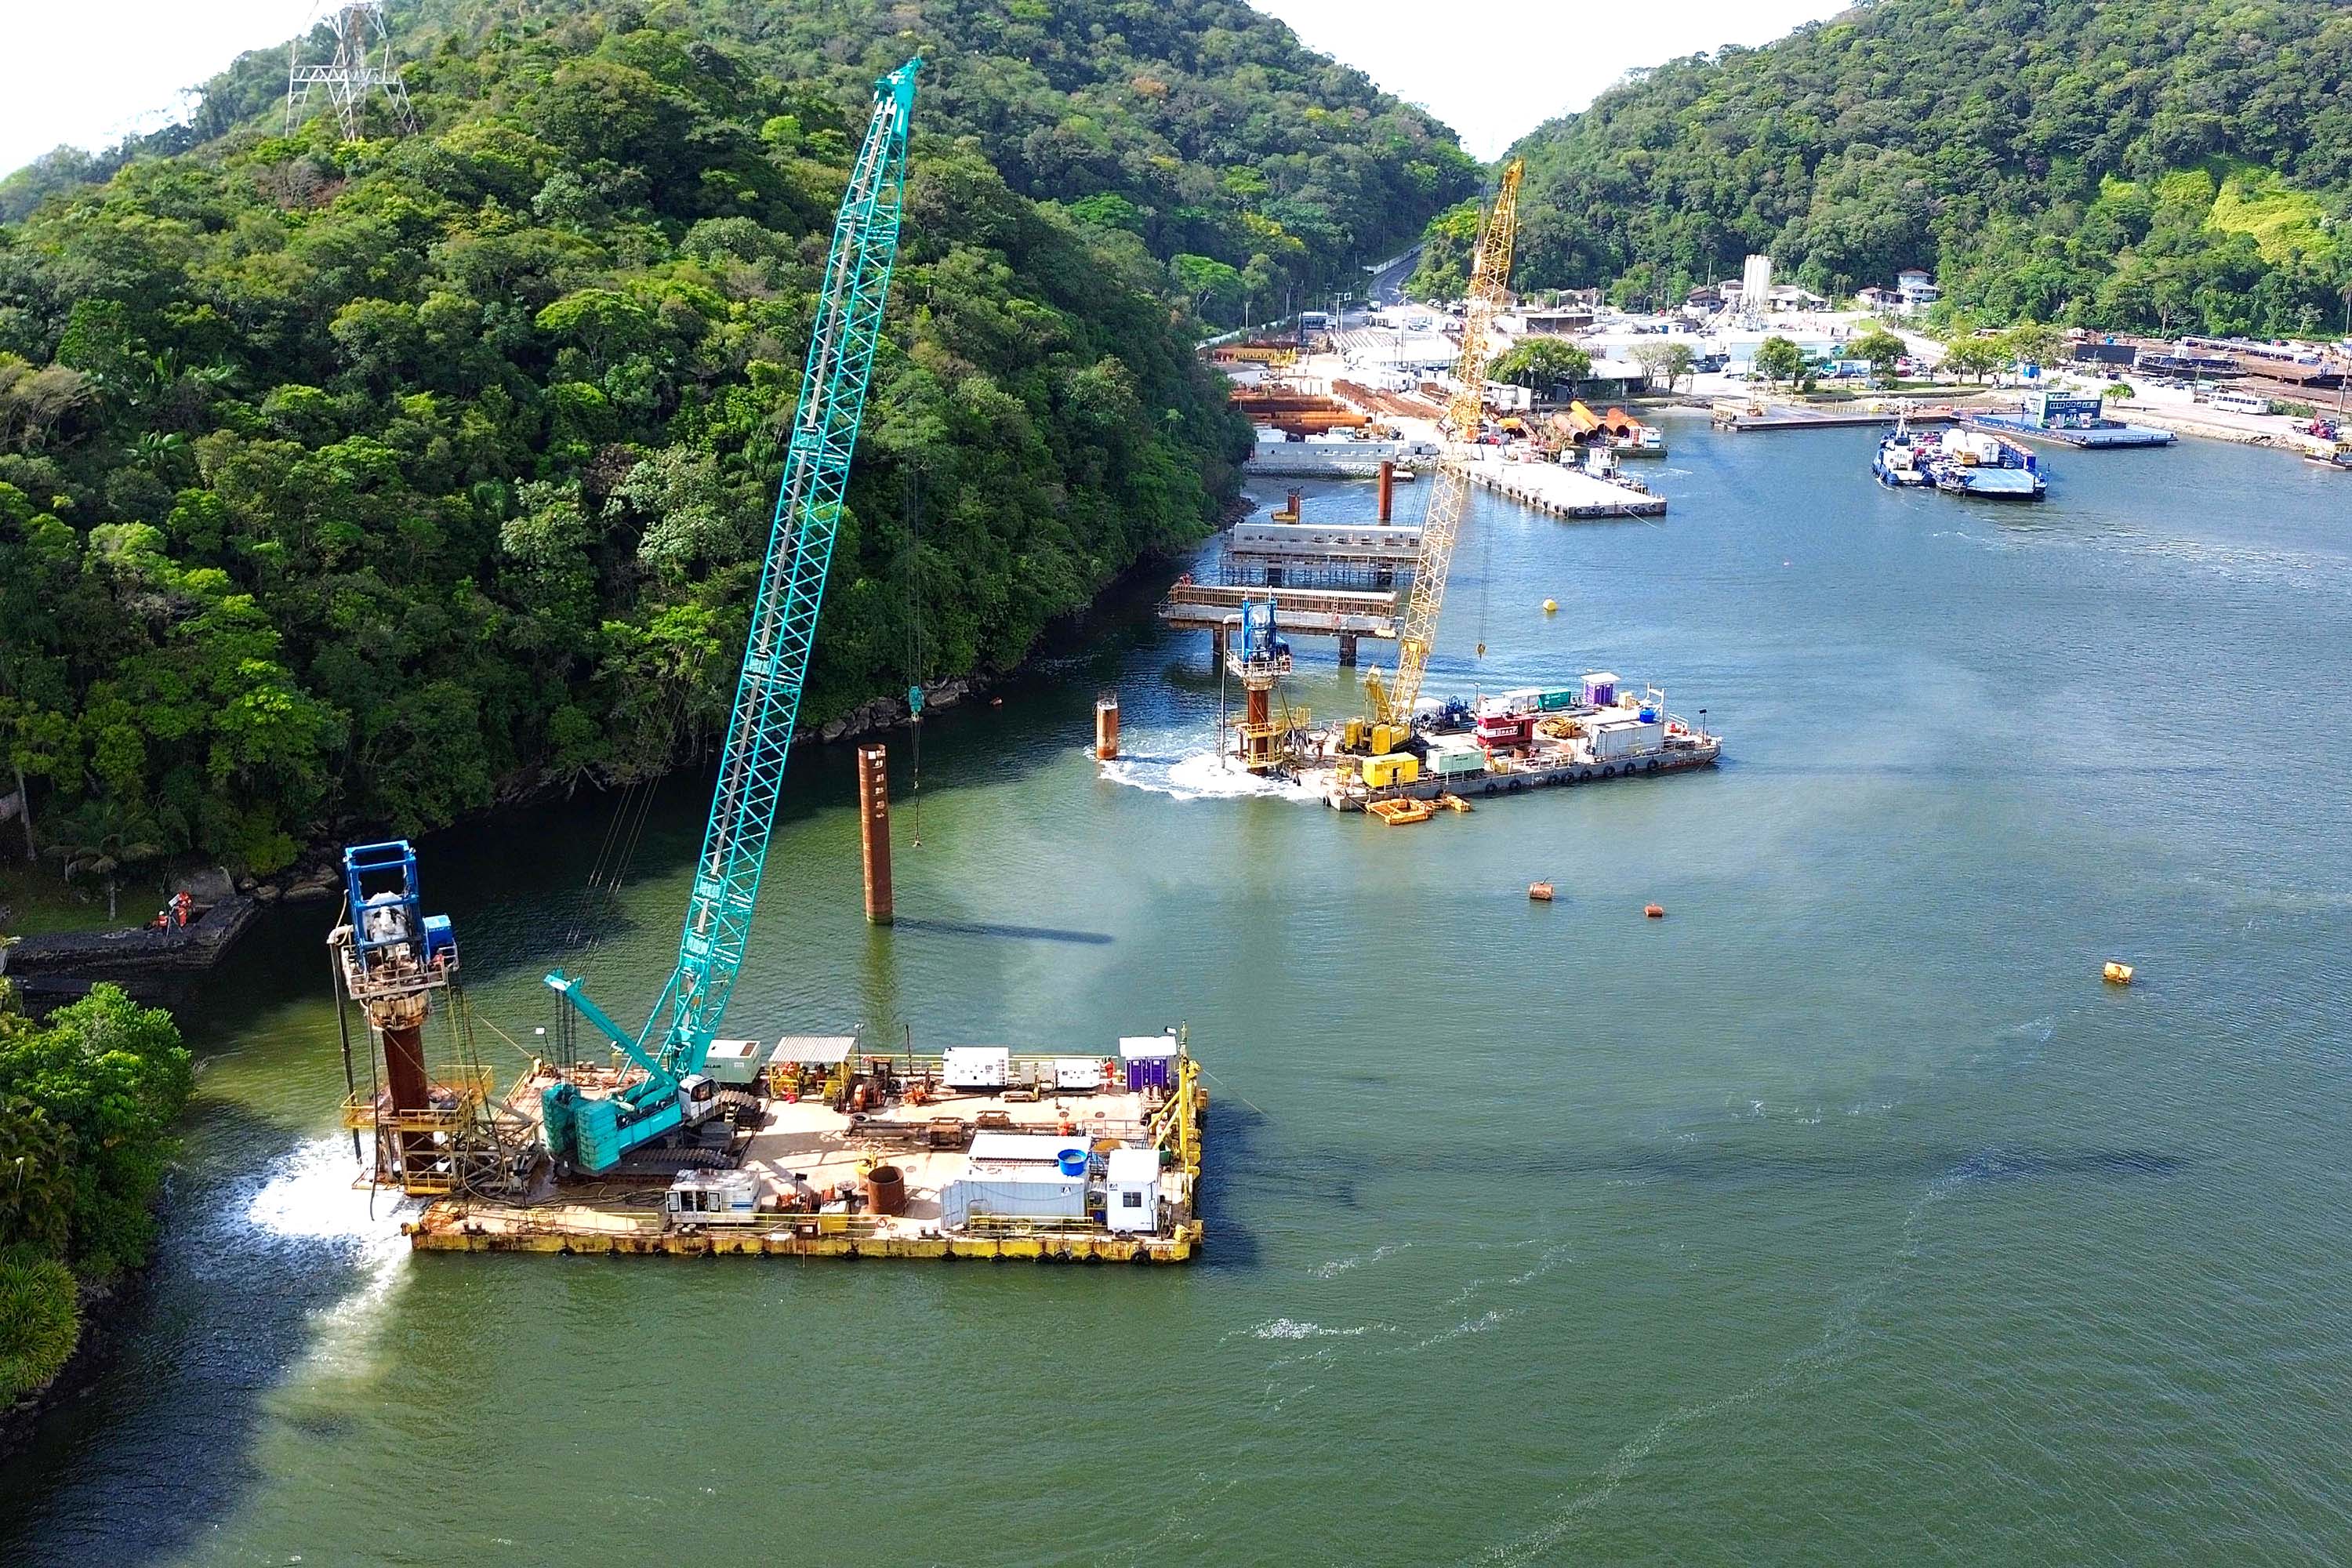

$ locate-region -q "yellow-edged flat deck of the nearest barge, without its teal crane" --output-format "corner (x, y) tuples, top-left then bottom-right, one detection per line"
(405, 1036), (1209, 1262)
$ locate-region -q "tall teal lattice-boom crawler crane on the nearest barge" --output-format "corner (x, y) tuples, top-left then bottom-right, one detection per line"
(541, 59), (922, 1173)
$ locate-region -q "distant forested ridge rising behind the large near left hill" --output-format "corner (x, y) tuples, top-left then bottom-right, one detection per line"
(0, 0), (1477, 325)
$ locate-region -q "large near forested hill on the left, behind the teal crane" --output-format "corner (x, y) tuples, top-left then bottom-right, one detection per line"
(0, 0), (1430, 869)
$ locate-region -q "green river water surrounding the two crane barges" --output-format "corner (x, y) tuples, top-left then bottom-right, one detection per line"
(0, 421), (2352, 1568)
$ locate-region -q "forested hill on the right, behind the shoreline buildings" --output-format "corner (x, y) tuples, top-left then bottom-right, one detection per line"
(1486, 0), (2352, 332)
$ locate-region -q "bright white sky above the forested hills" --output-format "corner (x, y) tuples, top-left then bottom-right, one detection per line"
(0, 0), (1842, 172)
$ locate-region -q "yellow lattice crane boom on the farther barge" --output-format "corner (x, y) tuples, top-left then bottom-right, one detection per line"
(1364, 160), (1519, 750)
